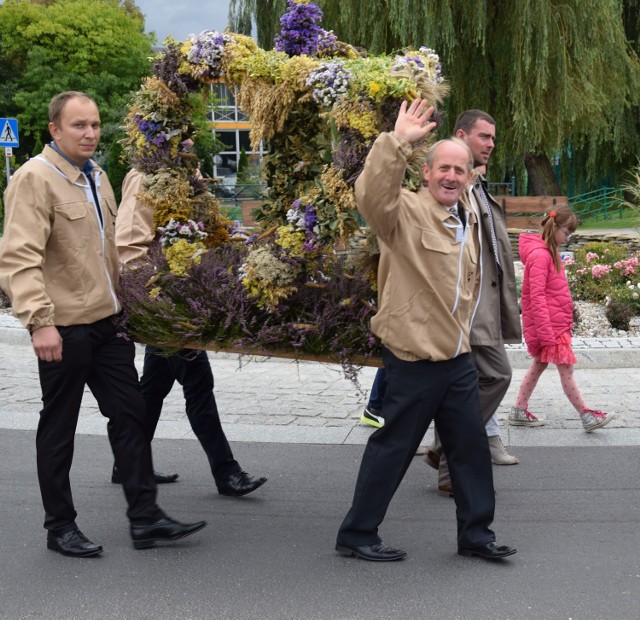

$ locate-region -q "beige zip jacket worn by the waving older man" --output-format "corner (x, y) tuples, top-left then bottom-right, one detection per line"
(356, 133), (479, 361)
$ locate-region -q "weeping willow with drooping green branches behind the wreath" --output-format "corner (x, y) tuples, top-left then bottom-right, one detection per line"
(229, 0), (640, 195)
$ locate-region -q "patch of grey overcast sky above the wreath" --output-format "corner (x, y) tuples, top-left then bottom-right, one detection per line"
(136, 0), (229, 43)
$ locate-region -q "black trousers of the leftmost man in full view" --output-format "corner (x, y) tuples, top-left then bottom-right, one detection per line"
(36, 318), (163, 533)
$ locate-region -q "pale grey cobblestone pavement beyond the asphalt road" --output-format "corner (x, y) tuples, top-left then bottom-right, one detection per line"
(0, 317), (640, 446)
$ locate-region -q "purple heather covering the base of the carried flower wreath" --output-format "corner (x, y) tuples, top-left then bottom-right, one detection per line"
(119, 244), (380, 378)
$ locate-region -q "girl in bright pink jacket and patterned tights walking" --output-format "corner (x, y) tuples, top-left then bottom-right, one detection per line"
(509, 205), (613, 433)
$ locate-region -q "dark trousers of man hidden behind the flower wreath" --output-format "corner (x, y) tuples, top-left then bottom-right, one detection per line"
(140, 346), (241, 482)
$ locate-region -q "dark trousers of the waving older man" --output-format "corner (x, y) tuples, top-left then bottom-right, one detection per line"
(338, 350), (495, 547)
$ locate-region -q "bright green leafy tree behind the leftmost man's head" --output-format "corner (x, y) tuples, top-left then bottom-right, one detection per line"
(0, 0), (153, 165)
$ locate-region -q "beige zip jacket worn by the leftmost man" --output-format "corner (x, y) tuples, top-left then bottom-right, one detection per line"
(0, 146), (120, 330)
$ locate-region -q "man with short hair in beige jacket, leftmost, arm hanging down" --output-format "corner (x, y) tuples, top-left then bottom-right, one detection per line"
(0, 92), (206, 557)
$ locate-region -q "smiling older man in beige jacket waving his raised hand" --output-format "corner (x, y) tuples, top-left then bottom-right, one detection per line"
(336, 100), (516, 562)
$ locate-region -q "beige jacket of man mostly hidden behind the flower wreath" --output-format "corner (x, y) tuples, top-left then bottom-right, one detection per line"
(116, 169), (154, 265)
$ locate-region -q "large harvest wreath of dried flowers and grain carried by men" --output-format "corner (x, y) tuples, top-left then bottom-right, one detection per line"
(116, 0), (447, 376)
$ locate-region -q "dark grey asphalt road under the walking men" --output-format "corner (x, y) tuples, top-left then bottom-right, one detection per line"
(0, 429), (640, 620)
